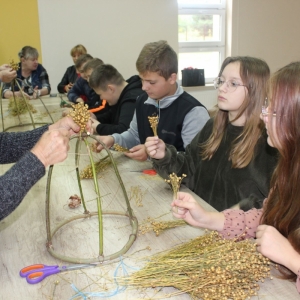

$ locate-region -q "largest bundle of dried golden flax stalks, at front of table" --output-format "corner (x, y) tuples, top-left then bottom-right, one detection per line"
(118, 232), (270, 300)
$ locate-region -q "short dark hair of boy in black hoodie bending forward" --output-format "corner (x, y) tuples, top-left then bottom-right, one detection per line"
(89, 64), (125, 91)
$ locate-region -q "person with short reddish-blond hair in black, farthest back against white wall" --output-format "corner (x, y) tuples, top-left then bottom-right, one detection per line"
(57, 44), (87, 93)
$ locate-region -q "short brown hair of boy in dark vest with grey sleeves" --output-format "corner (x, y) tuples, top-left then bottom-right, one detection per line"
(136, 41), (178, 79)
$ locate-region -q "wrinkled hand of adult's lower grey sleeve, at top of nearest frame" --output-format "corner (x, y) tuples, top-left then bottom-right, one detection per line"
(31, 128), (70, 167)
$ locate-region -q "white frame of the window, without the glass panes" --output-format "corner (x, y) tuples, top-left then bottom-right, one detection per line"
(177, 0), (226, 84)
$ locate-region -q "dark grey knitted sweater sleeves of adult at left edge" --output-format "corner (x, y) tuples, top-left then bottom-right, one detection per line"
(0, 125), (48, 220)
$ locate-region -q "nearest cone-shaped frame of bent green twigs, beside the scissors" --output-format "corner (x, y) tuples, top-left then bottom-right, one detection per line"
(46, 134), (138, 263)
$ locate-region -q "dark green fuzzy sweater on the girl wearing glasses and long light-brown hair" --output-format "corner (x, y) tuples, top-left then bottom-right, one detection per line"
(152, 119), (278, 211)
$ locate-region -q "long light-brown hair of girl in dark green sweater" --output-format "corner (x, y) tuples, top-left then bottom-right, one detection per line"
(201, 56), (270, 168)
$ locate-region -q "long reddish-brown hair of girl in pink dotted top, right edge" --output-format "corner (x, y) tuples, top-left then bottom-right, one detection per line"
(262, 62), (300, 279)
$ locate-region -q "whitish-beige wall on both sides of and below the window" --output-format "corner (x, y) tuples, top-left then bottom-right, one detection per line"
(38, 0), (300, 109)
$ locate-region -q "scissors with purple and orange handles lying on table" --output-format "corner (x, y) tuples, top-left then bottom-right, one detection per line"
(20, 264), (96, 284)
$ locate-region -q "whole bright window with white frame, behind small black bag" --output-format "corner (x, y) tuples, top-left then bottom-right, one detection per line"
(177, 0), (226, 83)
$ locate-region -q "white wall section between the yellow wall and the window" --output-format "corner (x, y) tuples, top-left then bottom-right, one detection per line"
(38, 0), (178, 92)
